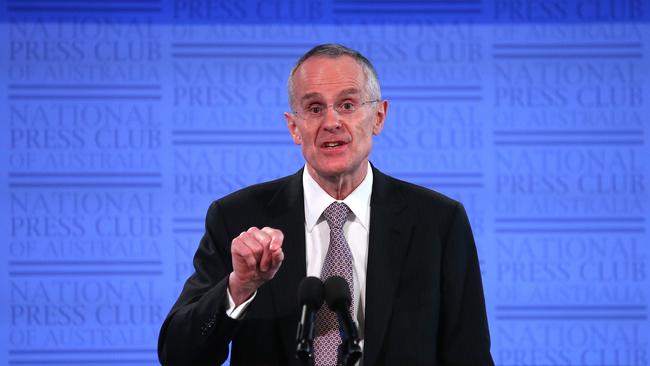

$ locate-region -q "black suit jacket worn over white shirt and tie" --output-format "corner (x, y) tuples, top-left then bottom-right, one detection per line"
(158, 167), (493, 366)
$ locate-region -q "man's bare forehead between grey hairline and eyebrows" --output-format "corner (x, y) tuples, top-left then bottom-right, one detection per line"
(293, 56), (366, 100)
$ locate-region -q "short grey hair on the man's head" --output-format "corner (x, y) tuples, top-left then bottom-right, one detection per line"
(287, 43), (381, 108)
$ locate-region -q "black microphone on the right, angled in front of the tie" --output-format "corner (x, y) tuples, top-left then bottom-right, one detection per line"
(325, 276), (361, 366)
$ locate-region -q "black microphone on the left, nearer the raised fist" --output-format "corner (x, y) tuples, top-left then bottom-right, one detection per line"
(296, 277), (325, 365)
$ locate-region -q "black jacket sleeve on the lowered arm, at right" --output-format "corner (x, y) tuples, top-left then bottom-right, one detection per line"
(438, 203), (494, 366)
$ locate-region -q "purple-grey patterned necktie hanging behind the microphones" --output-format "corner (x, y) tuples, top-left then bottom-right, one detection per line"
(314, 202), (354, 366)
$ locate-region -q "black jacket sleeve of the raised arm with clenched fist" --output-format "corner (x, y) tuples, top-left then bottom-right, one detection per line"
(158, 201), (239, 366)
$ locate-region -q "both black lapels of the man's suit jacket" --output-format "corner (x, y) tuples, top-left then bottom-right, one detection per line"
(262, 167), (411, 365)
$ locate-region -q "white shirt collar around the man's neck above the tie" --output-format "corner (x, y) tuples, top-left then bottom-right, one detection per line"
(302, 163), (373, 232)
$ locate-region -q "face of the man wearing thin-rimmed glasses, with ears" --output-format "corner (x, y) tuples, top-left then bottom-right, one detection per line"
(285, 56), (388, 179)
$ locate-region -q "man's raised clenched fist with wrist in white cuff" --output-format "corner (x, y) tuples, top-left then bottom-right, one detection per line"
(228, 227), (284, 306)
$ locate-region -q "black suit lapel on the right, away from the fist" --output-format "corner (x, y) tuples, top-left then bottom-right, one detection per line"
(364, 167), (411, 365)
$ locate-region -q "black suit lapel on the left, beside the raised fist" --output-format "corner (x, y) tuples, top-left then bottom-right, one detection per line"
(269, 169), (307, 362)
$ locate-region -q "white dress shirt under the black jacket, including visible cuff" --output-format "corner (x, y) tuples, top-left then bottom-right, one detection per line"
(226, 163), (373, 347)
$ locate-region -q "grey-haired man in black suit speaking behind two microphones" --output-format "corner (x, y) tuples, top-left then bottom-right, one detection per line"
(158, 45), (493, 366)
